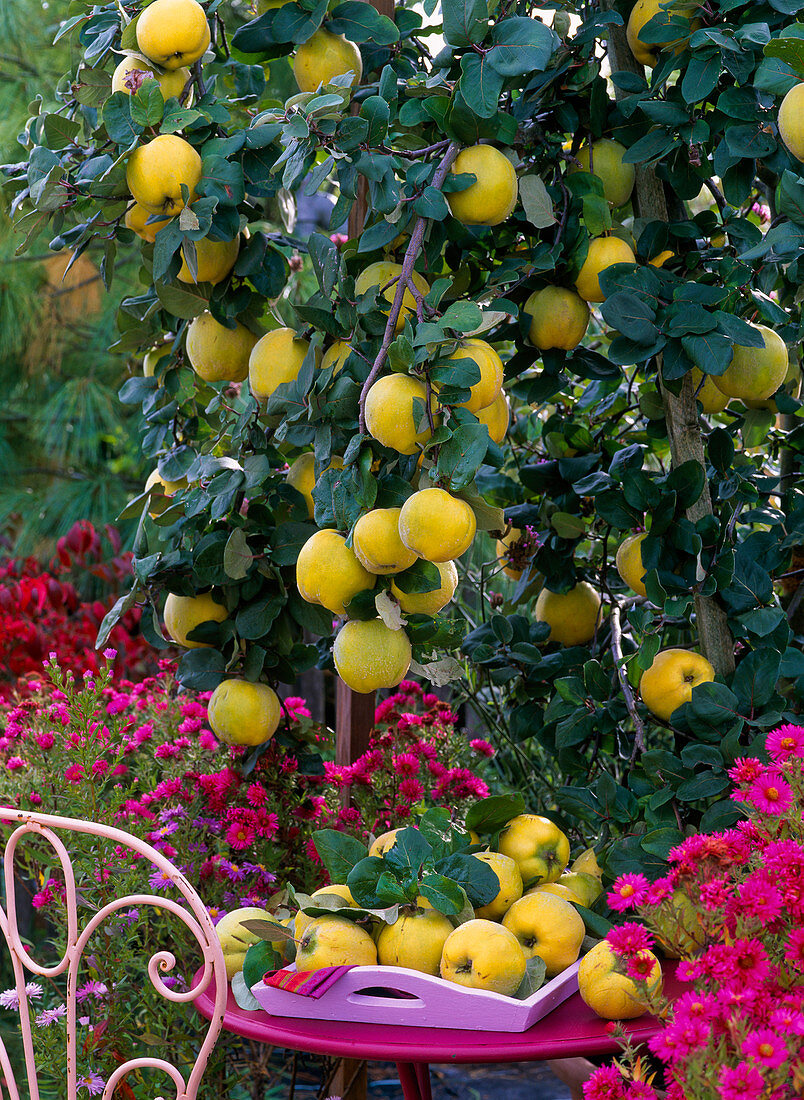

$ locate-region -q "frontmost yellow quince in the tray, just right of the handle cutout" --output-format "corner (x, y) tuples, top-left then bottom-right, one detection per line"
(439, 917), (526, 997)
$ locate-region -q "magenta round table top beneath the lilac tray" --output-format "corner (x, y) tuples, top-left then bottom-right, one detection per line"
(194, 963), (684, 1063)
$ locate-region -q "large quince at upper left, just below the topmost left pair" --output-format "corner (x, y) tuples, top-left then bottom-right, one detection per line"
(125, 134), (201, 215)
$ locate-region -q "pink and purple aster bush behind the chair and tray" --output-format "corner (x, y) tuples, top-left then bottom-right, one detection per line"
(0, 650), (493, 1100)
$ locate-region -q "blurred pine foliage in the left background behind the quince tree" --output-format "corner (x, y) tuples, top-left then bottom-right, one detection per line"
(0, 0), (144, 553)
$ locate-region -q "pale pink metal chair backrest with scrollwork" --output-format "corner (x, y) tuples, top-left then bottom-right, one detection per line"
(0, 806), (227, 1100)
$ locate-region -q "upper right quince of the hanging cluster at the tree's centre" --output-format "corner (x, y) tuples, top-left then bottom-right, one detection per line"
(399, 488), (477, 562)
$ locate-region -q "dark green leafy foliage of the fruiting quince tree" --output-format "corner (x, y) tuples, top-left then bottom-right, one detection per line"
(4, 0), (804, 873)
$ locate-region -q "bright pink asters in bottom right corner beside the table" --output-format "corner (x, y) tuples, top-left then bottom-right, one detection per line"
(584, 725), (804, 1100)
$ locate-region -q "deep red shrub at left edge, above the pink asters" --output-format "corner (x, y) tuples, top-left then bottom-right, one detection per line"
(0, 520), (151, 699)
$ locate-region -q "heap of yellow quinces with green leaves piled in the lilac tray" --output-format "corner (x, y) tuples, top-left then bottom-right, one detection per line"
(217, 796), (641, 1011)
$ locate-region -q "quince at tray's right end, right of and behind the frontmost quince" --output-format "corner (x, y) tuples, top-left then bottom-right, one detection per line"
(503, 891), (586, 978)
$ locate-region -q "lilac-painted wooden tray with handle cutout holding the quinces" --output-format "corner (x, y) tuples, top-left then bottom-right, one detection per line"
(252, 963), (581, 1032)
